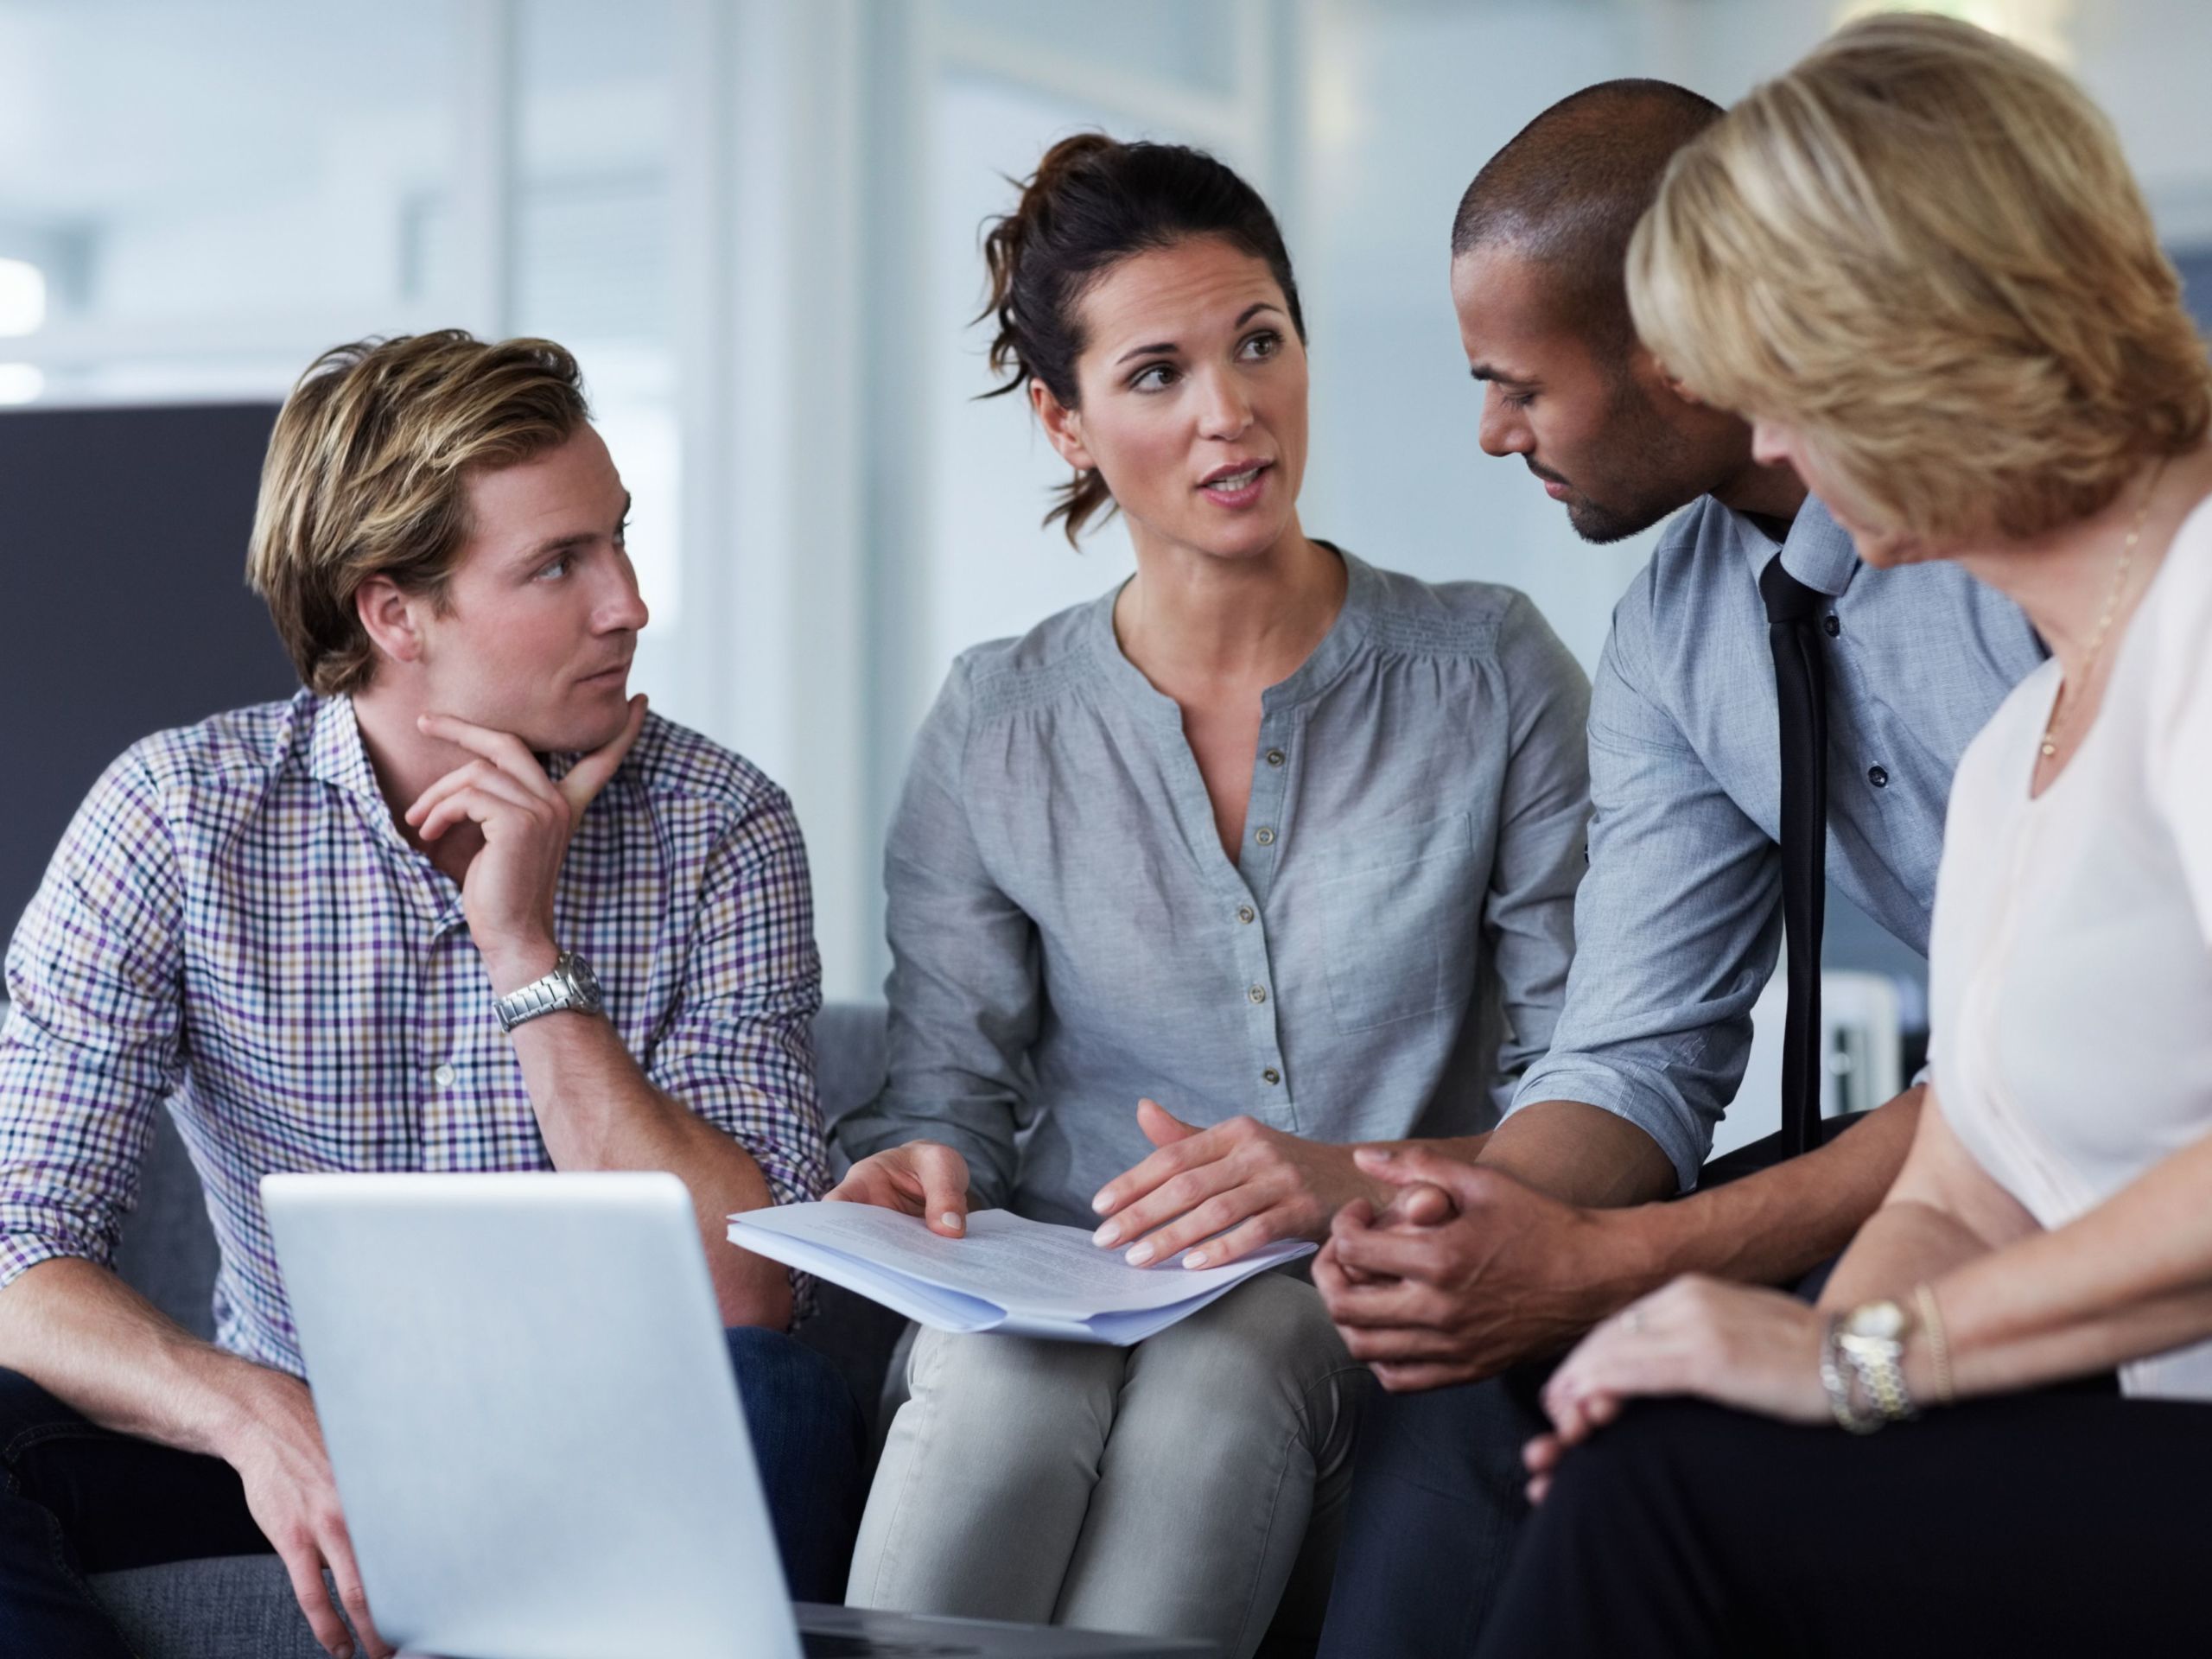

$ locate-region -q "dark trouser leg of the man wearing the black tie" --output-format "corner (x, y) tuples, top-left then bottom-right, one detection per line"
(1320, 1365), (1551, 1659)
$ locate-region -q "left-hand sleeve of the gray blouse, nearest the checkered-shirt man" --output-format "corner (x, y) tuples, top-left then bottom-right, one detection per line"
(836, 664), (1042, 1210)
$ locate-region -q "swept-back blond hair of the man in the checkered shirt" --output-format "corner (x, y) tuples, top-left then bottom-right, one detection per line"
(245, 329), (591, 696)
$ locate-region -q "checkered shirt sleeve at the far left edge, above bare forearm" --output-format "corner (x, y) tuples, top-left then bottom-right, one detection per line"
(0, 754), (183, 1285)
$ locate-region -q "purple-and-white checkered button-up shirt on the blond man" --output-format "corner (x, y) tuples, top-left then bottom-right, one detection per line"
(0, 692), (827, 1376)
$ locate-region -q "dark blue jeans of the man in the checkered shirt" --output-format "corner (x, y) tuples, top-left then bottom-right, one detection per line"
(0, 1330), (865, 1659)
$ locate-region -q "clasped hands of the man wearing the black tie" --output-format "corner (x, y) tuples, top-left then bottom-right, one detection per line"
(1314, 1148), (1650, 1394)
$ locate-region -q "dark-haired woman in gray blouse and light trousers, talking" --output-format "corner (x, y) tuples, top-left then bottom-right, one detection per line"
(832, 135), (1588, 1655)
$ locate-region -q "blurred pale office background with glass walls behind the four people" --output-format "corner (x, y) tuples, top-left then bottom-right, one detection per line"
(0, 0), (2212, 1026)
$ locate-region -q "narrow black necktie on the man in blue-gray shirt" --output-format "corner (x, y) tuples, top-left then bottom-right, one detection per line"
(1758, 553), (1827, 1157)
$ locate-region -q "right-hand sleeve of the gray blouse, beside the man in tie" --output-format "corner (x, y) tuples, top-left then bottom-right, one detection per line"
(1484, 597), (1591, 1106)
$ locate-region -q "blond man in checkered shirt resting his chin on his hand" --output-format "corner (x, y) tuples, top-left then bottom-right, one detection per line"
(0, 332), (861, 1659)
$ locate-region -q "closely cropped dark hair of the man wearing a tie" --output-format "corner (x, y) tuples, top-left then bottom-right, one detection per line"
(1451, 79), (1721, 347)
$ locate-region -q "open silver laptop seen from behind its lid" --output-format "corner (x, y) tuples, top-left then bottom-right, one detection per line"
(261, 1174), (1212, 1659)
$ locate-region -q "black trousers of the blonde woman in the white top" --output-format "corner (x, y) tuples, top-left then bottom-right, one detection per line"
(1478, 1391), (2212, 1659)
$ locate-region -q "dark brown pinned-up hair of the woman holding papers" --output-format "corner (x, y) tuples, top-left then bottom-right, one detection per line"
(978, 133), (1305, 542)
